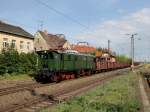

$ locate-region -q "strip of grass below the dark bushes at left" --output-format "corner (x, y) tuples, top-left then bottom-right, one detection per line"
(0, 74), (31, 81)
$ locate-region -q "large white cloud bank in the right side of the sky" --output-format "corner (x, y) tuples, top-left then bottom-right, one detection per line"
(74, 8), (150, 60)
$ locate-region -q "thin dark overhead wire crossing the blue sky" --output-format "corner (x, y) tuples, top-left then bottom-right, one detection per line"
(35, 0), (90, 30)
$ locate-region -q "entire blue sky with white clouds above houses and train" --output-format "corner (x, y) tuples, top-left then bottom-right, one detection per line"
(0, 0), (150, 60)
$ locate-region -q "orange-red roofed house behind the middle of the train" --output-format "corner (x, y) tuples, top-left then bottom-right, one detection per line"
(72, 42), (96, 54)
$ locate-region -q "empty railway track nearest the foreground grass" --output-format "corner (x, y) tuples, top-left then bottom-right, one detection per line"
(0, 69), (129, 112)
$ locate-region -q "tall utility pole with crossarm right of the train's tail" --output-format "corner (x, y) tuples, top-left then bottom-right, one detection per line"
(127, 33), (137, 70)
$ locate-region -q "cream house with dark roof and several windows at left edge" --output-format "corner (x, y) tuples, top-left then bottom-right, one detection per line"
(0, 21), (34, 53)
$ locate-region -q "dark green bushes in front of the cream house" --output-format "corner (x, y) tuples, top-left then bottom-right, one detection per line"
(0, 48), (37, 76)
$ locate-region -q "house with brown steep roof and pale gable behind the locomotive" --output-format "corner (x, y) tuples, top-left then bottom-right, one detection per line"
(34, 30), (71, 51)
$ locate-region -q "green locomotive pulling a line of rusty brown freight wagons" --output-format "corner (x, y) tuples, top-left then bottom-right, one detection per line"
(35, 50), (130, 83)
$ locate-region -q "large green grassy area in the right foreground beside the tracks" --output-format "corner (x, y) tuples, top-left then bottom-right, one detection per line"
(41, 73), (141, 112)
